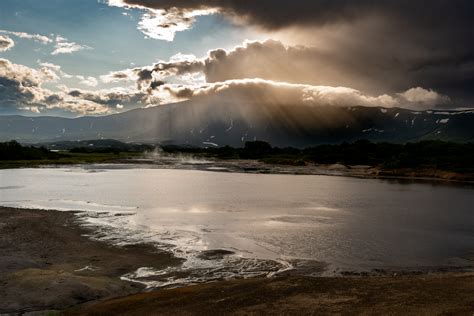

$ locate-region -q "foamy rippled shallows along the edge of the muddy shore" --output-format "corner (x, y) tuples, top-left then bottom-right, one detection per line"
(74, 212), (320, 288)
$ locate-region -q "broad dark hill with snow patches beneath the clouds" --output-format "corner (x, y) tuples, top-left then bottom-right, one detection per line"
(0, 101), (474, 147)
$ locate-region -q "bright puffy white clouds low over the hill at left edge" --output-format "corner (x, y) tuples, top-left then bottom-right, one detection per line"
(0, 58), (148, 115)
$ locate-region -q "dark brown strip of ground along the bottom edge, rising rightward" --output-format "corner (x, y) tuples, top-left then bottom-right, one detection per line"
(66, 274), (474, 315)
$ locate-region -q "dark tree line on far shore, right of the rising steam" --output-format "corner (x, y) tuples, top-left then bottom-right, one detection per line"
(163, 140), (474, 172)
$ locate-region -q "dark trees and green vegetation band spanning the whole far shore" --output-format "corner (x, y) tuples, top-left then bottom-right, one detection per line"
(0, 140), (474, 182)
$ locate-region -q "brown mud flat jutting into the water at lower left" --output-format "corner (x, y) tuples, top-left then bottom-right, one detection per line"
(0, 207), (180, 314)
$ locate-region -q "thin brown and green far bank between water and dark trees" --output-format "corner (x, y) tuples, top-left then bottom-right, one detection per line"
(0, 155), (474, 184)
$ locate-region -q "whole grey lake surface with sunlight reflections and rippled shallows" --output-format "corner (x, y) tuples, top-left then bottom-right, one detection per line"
(0, 166), (474, 286)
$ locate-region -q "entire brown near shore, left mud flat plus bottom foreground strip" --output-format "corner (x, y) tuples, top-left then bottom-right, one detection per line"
(0, 207), (474, 315)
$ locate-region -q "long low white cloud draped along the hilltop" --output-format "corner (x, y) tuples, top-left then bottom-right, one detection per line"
(156, 79), (456, 110)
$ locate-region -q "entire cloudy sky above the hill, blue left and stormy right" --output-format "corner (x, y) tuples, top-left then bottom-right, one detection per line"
(0, 0), (474, 117)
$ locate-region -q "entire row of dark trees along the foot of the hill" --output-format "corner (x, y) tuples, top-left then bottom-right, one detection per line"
(0, 140), (474, 173)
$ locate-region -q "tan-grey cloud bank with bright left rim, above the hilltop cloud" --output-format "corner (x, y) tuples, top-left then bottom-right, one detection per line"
(109, 40), (454, 106)
